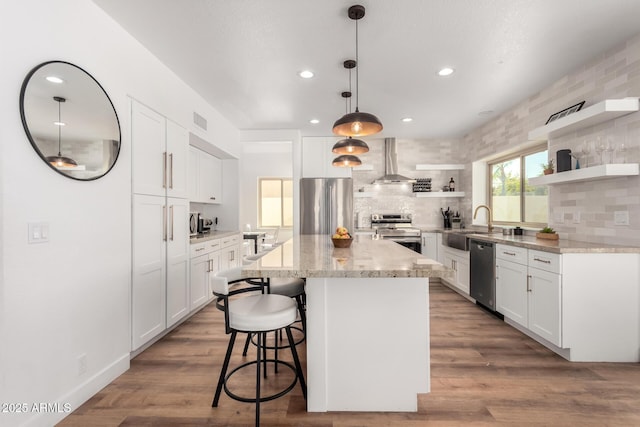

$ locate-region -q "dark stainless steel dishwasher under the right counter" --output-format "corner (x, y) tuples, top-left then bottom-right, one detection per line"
(469, 239), (496, 311)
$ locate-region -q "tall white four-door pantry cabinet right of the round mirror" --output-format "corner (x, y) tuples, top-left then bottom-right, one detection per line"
(131, 100), (189, 350)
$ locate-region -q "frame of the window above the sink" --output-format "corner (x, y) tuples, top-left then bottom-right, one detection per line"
(487, 142), (549, 228)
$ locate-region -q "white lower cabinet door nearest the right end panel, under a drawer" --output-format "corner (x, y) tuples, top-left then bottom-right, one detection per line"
(529, 268), (562, 347)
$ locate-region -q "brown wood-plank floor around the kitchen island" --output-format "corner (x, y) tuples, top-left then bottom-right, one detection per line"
(59, 283), (640, 427)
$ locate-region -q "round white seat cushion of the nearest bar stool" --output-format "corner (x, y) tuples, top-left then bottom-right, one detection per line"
(229, 294), (298, 332)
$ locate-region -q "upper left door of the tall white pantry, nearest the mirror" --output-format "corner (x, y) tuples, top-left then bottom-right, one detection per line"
(131, 101), (168, 196)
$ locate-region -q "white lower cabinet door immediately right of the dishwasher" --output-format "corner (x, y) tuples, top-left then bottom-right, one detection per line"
(496, 259), (528, 327)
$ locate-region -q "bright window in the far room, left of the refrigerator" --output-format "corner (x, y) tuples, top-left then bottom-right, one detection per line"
(258, 178), (293, 227)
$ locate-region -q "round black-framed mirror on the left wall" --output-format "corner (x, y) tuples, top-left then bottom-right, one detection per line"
(20, 61), (120, 181)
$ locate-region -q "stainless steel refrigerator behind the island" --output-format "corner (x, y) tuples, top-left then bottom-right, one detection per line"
(300, 178), (353, 234)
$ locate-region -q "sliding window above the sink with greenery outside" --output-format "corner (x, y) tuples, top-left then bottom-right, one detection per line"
(489, 145), (549, 226)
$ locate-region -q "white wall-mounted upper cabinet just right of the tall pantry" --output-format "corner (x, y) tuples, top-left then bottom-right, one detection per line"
(189, 147), (223, 204)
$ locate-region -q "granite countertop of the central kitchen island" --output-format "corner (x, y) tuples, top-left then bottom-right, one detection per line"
(243, 235), (453, 278)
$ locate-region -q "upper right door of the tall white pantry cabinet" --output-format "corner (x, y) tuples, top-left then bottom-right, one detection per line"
(166, 120), (189, 199)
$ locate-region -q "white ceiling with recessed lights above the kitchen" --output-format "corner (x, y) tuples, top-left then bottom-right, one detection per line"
(94, 0), (640, 139)
